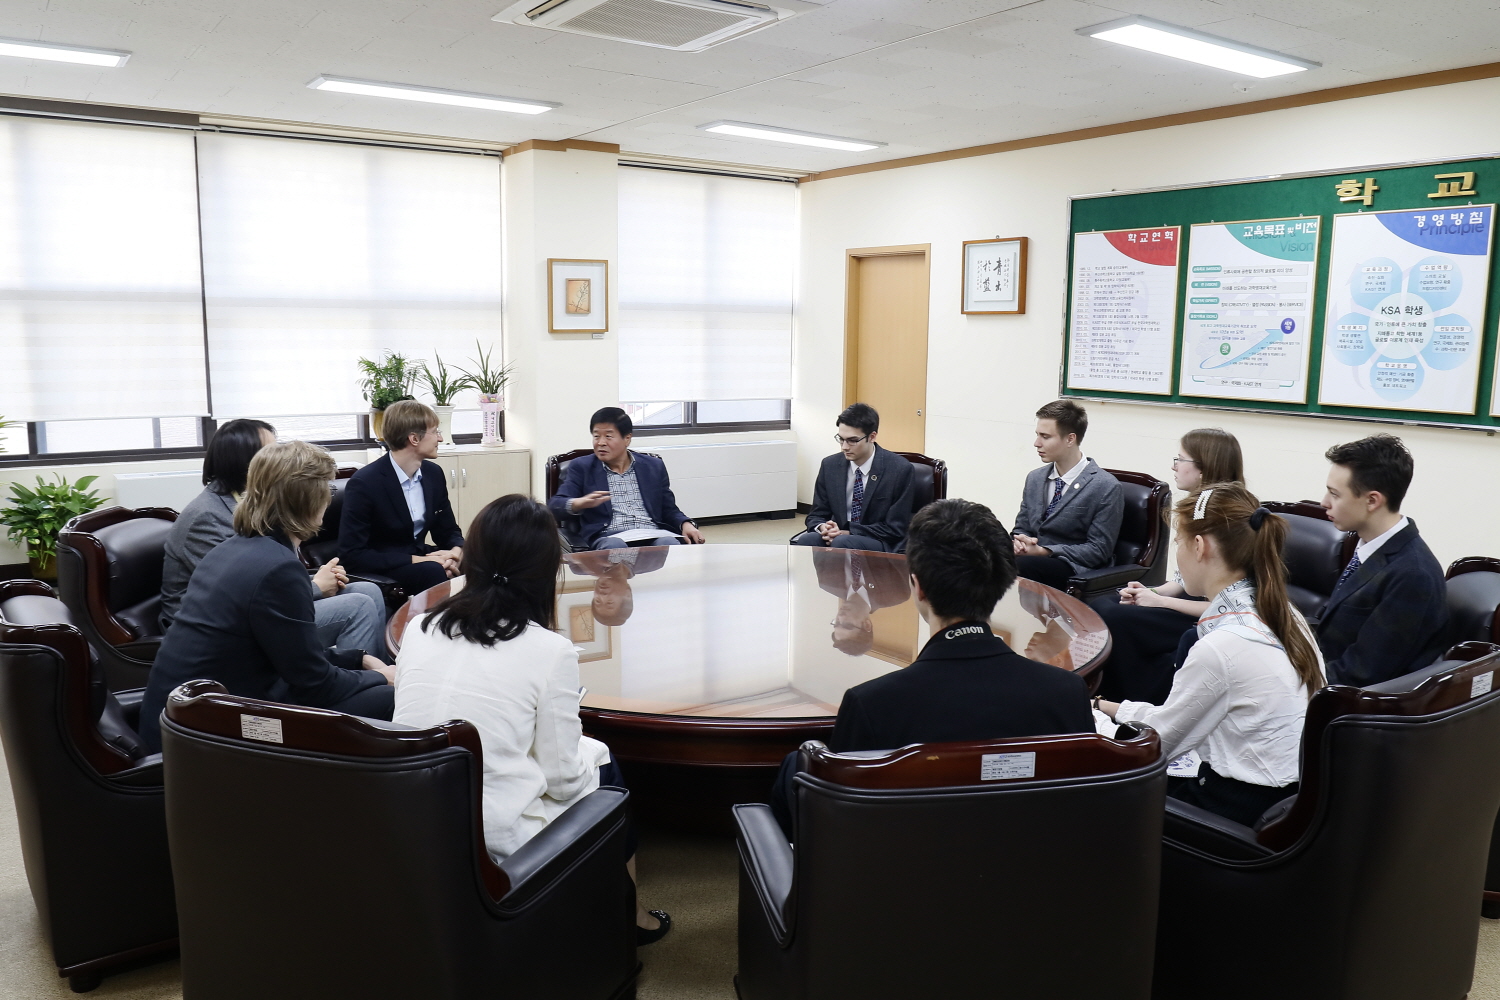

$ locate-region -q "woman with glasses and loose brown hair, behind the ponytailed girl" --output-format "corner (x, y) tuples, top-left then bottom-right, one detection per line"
(1091, 427), (1245, 705)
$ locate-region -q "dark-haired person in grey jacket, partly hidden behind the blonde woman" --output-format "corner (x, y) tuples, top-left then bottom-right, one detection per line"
(161, 420), (386, 657)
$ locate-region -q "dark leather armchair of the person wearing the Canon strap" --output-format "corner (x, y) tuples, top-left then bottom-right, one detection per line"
(734, 730), (1167, 1000)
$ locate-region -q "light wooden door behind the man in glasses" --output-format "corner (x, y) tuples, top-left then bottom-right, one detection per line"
(845, 246), (929, 451)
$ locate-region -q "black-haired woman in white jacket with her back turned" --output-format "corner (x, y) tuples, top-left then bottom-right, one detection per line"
(393, 493), (672, 945)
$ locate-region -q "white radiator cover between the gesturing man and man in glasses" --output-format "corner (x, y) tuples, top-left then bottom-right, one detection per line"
(648, 441), (797, 517)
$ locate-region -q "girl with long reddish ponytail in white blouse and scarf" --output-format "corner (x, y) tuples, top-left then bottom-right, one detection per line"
(1095, 483), (1323, 826)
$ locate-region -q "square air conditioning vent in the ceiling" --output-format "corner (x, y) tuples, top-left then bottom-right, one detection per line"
(495, 0), (794, 52)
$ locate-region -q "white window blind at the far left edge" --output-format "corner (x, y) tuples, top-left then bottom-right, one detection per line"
(0, 118), (209, 420)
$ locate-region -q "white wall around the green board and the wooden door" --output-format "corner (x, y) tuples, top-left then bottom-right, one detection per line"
(792, 81), (1500, 565)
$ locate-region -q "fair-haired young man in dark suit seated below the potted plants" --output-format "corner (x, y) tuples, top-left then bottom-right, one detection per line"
(339, 399), (464, 595)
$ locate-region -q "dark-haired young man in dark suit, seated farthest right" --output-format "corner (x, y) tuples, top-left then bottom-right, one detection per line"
(1317, 435), (1448, 687)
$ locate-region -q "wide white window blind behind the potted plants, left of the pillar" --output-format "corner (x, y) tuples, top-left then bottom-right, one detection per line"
(198, 135), (501, 418)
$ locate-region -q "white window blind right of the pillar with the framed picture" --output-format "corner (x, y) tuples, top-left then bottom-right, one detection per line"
(620, 166), (798, 402)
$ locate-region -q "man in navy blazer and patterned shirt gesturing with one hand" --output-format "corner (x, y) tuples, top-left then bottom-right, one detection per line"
(548, 406), (705, 550)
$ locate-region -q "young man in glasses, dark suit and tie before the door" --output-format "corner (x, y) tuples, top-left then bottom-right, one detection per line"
(794, 403), (915, 552)
